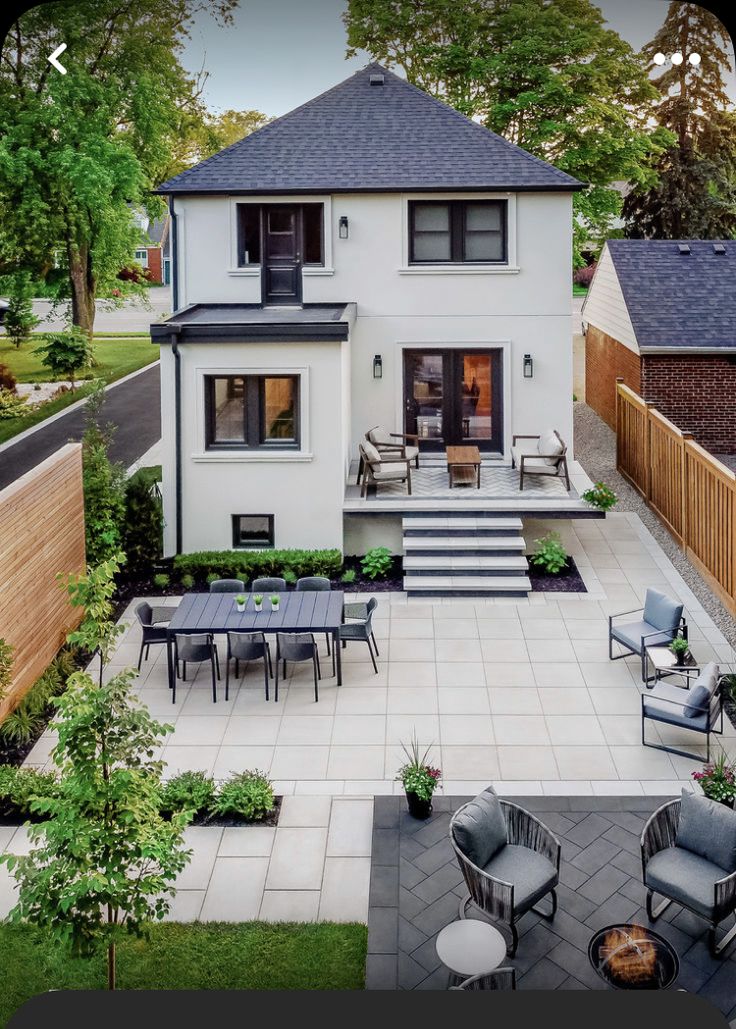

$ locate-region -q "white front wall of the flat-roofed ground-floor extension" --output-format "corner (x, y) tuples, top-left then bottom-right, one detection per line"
(161, 343), (346, 554)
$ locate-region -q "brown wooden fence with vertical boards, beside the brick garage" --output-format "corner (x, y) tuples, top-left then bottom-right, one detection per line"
(616, 380), (736, 613)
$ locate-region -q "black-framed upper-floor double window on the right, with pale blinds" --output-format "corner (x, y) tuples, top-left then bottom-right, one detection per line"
(409, 200), (509, 264)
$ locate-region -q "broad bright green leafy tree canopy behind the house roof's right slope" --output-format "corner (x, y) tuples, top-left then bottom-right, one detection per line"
(345, 0), (671, 263)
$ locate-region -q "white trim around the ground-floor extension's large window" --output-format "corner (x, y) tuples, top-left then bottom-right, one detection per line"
(189, 364), (314, 464)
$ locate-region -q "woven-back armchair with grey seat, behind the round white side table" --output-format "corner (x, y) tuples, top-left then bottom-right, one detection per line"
(450, 801), (560, 957)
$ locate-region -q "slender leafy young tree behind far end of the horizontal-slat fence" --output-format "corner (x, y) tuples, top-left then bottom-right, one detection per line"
(81, 386), (126, 566)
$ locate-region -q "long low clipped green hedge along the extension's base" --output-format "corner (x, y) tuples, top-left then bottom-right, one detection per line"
(174, 551), (343, 582)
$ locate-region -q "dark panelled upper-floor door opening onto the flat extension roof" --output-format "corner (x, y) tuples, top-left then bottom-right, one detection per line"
(261, 204), (302, 304)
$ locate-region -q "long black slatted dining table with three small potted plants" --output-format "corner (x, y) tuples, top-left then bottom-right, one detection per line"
(166, 590), (345, 702)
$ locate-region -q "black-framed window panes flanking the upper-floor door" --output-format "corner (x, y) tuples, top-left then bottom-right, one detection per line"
(238, 204), (324, 268)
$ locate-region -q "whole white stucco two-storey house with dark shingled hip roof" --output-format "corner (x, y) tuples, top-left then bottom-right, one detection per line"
(151, 64), (597, 592)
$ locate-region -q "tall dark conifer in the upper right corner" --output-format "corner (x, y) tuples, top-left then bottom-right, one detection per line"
(624, 2), (736, 239)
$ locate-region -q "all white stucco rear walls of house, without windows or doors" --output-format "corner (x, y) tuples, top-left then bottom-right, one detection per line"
(162, 185), (573, 553)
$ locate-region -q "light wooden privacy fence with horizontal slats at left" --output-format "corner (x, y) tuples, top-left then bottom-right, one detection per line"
(0, 443), (84, 721)
